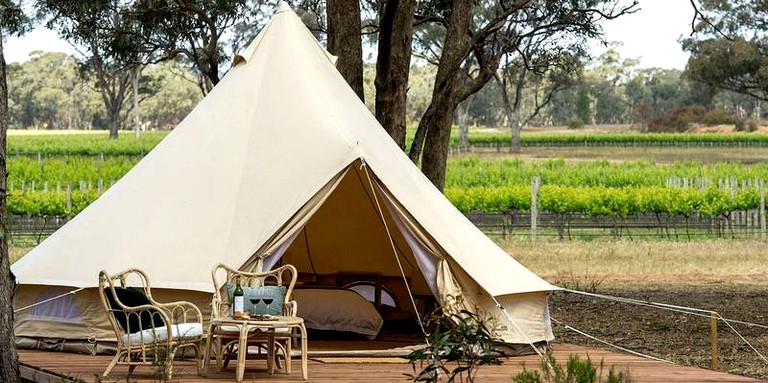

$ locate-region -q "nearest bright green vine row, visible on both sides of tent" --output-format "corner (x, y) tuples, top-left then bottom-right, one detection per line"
(8, 179), (765, 217)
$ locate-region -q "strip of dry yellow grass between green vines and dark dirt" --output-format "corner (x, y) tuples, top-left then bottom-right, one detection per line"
(500, 239), (768, 287)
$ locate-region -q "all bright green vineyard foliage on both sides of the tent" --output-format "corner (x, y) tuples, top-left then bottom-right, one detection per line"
(8, 133), (768, 217)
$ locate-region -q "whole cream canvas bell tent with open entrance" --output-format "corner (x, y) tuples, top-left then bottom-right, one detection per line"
(12, 4), (557, 351)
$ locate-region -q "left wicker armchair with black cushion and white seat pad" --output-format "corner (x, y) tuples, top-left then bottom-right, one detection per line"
(99, 269), (203, 379)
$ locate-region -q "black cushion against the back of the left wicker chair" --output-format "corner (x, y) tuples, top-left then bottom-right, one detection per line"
(104, 287), (165, 333)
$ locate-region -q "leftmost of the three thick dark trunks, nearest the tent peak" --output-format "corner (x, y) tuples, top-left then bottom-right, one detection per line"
(326, 0), (365, 101)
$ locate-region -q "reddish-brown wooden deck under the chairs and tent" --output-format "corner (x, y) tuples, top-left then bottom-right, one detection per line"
(19, 344), (759, 383)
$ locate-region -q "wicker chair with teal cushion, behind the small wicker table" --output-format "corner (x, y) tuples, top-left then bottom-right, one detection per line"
(208, 264), (298, 374)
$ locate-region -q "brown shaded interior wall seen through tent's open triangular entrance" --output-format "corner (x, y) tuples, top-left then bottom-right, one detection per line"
(249, 159), (442, 296)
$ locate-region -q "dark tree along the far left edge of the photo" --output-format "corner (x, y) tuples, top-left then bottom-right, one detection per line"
(0, 0), (27, 383)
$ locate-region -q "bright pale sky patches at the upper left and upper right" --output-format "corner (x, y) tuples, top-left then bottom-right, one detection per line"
(4, 0), (693, 70)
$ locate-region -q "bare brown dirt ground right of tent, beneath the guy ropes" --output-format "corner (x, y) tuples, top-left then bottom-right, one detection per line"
(550, 283), (768, 380)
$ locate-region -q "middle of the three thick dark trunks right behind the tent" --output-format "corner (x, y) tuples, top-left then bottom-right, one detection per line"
(374, 0), (415, 149)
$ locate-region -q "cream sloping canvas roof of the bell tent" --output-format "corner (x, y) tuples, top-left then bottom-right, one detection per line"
(12, 3), (557, 295)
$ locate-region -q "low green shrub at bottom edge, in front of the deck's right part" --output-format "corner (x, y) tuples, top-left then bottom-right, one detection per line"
(513, 353), (630, 383)
